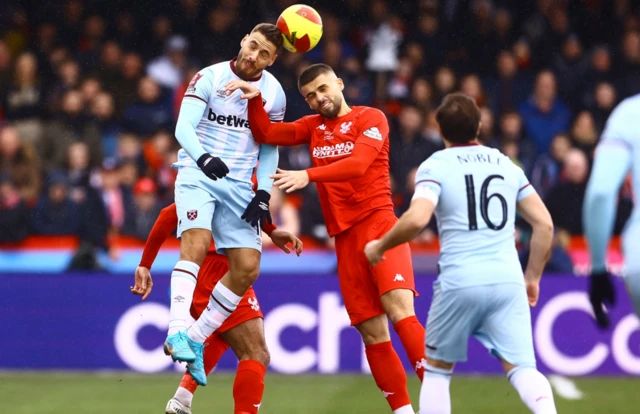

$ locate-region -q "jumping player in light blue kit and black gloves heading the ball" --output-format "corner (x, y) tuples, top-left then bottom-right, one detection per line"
(165, 23), (286, 385)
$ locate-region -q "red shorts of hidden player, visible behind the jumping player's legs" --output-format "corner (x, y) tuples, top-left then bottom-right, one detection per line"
(190, 253), (264, 333)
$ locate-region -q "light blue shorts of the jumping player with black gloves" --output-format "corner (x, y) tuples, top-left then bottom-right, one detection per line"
(175, 167), (262, 254)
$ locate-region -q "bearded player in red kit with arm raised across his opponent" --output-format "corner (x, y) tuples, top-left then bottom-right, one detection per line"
(226, 64), (425, 414)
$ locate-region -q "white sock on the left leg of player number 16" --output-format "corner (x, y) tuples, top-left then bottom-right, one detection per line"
(419, 365), (453, 414)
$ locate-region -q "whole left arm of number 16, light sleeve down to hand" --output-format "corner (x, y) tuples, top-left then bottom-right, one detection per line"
(365, 159), (441, 266)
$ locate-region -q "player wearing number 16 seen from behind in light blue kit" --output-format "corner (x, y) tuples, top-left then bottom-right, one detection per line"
(365, 93), (556, 414)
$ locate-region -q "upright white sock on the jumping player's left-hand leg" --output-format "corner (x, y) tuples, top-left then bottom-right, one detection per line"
(169, 260), (200, 336)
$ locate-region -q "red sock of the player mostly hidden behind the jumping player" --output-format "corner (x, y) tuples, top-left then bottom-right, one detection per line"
(233, 359), (267, 414)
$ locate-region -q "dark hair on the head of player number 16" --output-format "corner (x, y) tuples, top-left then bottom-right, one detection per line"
(436, 92), (480, 144)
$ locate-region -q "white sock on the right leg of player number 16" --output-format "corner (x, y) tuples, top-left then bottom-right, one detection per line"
(507, 367), (557, 414)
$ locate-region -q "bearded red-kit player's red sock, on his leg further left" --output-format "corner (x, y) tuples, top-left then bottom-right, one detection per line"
(365, 341), (411, 411)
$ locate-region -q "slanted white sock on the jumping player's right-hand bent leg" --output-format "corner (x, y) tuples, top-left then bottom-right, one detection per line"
(187, 282), (242, 344)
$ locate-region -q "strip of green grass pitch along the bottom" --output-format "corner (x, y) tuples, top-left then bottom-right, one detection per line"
(0, 373), (640, 414)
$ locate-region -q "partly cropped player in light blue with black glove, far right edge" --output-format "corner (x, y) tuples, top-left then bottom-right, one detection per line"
(583, 95), (640, 328)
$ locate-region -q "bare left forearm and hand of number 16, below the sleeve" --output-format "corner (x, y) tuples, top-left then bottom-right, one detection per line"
(364, 197), (436, 266)
